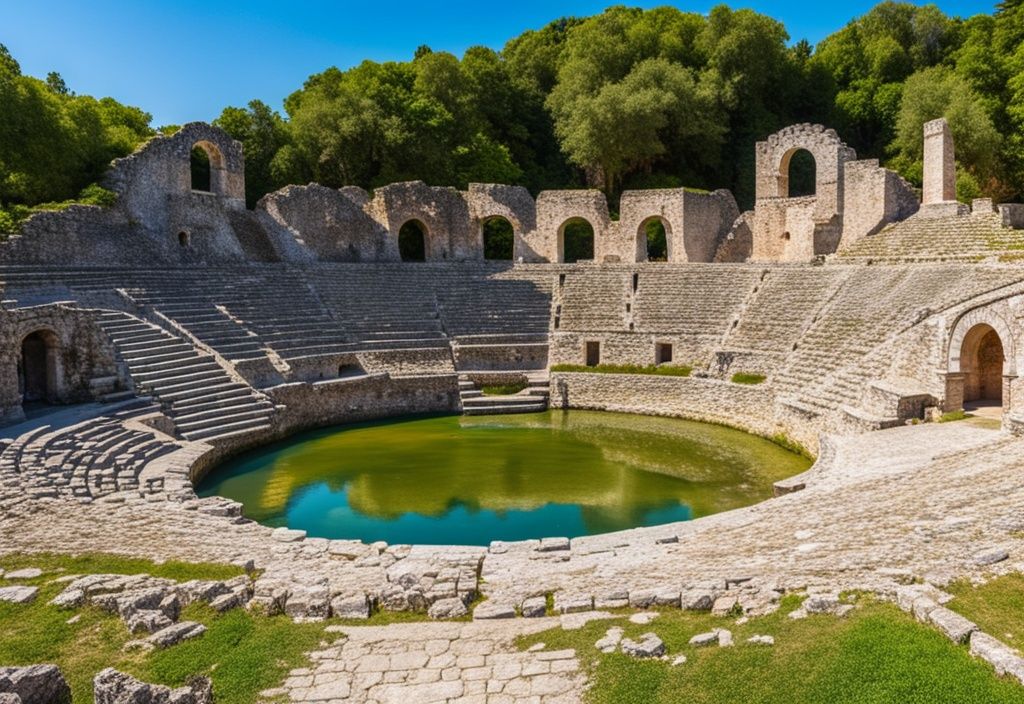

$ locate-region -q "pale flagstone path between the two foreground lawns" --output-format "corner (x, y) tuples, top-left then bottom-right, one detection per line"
(265, 618), (585, 704)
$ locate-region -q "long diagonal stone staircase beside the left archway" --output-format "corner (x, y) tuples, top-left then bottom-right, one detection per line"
(98, 311), (274, 441)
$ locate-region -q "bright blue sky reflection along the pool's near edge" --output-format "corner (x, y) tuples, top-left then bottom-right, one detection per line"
(281, 484), (690, 545)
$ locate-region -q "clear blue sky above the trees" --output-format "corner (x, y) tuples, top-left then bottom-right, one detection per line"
(0, 0), (995, 126)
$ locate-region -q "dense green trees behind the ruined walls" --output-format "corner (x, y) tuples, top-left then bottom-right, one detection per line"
(0, 0), (1024, 220)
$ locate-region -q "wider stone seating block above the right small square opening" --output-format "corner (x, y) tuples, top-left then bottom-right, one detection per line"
(633, 264), (763, 337)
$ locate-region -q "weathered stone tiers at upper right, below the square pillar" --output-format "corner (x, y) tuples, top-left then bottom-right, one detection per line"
(839, 213), (1024, 261)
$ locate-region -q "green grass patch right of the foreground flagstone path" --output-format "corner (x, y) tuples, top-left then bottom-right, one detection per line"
(519, 598), (1024, 704)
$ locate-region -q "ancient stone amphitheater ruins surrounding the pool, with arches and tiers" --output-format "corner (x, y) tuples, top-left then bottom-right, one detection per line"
(0, 121), (1024, 701)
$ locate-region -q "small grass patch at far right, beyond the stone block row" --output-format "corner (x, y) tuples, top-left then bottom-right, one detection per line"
(946, 574), (1024, 649)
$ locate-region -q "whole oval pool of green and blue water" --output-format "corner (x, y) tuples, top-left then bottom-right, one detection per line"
(199, 410), (810, 545)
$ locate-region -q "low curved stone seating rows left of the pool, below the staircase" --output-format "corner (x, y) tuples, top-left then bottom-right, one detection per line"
(0, 402), (180, 502)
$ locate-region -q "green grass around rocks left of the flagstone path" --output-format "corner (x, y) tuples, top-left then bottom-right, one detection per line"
(0, 555), (324, 704)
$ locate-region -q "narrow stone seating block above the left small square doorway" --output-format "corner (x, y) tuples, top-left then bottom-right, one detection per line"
(556, 267), (632, 332)
